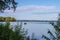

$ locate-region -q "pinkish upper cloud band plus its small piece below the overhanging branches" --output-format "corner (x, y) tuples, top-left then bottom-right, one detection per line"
(5, 5), (56, 13)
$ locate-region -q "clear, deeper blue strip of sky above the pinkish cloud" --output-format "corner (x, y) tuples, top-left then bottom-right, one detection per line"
(17, 0), (60, 6)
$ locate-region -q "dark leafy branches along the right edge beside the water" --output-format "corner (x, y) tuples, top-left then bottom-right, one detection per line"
(41, 14), (60, 40)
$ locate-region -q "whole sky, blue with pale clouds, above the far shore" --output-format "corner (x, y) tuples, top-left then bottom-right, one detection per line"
(0, 0), (60, 20)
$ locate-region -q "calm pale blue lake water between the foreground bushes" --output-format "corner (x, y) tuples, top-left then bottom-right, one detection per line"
(23, 22), (55, 40)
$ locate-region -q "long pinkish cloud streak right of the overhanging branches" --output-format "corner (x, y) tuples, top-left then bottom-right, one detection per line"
(17, 5), (55, 11)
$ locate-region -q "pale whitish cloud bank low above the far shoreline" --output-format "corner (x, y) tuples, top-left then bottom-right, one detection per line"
(15, 13), (58, 20)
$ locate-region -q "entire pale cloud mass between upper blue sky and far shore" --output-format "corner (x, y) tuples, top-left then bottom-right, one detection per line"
(1, 5), (58, 20)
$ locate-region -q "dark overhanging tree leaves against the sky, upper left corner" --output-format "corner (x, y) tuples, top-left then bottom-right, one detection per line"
(0, 0), (17, 12)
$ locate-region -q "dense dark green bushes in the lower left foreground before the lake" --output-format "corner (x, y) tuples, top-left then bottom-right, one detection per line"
(0, 22), (27, 40)
